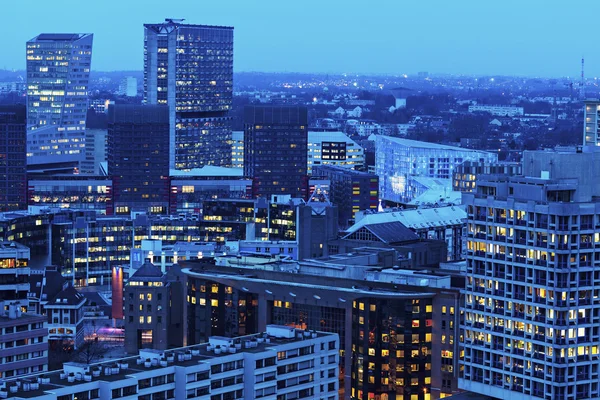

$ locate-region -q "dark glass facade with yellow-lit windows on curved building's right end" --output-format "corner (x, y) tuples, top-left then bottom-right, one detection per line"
(351, 298), (433, 400)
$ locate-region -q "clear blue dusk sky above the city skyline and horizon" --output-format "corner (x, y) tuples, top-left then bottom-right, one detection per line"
(0, 0), (600, 77)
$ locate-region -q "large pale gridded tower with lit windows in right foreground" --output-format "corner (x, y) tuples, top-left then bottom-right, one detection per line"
(459, 151), (600, 400)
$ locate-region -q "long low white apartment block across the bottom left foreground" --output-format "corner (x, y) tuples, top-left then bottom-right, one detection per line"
(0, 325), (339, 400)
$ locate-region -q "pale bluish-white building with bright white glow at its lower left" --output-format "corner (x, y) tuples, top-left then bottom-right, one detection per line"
(375, 135), (498, 203)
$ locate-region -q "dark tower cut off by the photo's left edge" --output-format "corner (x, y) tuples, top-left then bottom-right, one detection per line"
(0, 105), (27, 211)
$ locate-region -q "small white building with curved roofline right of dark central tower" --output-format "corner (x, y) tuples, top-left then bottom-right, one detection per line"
(308, 131), (365, 174)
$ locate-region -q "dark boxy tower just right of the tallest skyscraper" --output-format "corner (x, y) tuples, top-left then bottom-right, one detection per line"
(244, 106), (308, 198)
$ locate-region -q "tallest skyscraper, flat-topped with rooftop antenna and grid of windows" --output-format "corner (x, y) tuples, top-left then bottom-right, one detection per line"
(144, 19), (233, 169)
